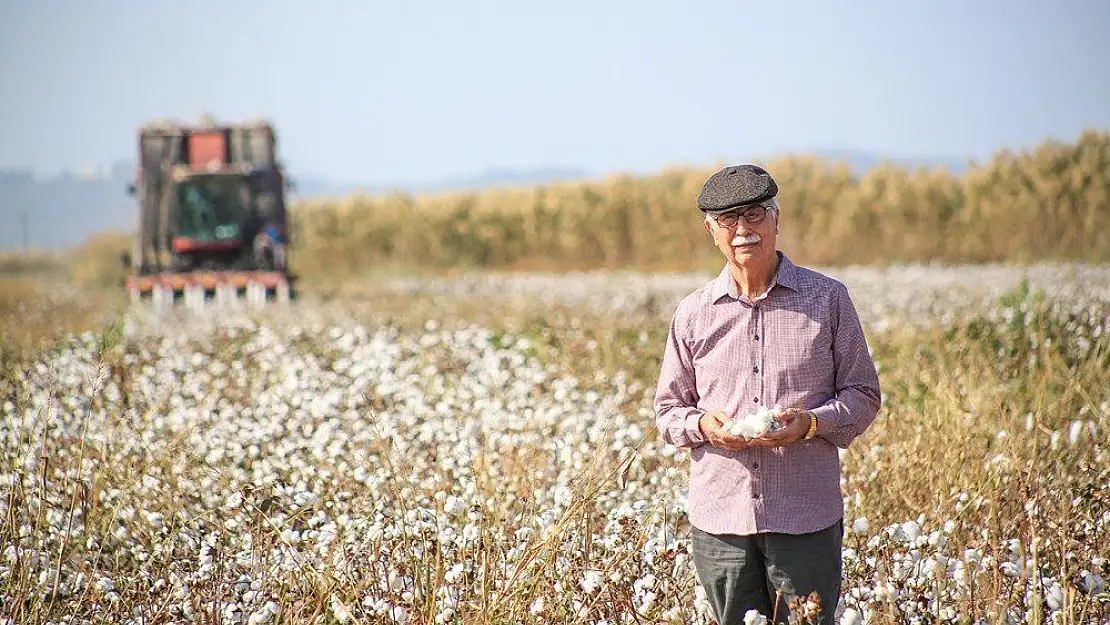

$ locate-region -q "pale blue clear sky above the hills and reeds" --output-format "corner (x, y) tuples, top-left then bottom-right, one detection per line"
(0, 0), (1110, 183)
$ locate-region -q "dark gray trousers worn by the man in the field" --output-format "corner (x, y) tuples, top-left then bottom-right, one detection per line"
(692, 520), (844, 625)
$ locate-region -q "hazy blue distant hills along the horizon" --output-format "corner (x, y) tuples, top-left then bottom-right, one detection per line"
(0, 150), (966, 251)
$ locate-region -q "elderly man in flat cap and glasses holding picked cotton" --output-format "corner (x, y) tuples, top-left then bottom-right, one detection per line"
(655, 164), (880, 625)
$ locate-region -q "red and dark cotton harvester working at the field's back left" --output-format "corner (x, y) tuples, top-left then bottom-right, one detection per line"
(123, 119), (293, 308)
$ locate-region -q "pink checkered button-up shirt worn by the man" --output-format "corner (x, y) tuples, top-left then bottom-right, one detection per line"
(655, 252), (880, 534)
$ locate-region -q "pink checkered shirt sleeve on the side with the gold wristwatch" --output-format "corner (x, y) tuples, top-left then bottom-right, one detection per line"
(814, 284), (881, 448)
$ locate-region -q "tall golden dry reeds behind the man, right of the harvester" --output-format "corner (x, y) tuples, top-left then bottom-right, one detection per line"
(293, 130), (1110, 274)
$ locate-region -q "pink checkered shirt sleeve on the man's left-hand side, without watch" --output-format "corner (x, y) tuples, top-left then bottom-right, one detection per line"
(655, 308), (706, 447)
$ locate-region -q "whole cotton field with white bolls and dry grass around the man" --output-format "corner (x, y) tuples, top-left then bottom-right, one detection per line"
(0, 268), (1110, 625)
